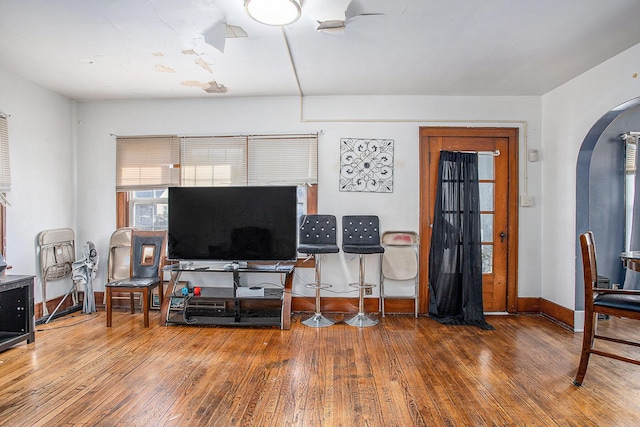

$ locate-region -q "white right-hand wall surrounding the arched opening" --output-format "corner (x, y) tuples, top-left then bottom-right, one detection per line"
(541, 41), (640, 322)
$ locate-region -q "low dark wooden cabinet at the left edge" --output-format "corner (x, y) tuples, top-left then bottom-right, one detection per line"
(0, 276), (36, 351)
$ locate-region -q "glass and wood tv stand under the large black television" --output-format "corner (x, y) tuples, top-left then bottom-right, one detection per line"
(160, 263), (294, 329)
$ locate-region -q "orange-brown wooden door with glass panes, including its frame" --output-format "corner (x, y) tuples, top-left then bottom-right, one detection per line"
(420, 127), (518, 313)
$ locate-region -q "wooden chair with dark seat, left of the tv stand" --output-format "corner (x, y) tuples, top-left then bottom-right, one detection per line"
(105, 230), (167, 328)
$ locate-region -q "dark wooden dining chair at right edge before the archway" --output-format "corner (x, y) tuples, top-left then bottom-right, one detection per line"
(573, 231), (640, 386)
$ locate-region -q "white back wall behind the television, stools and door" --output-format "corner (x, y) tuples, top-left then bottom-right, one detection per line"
(77, 96), (542, 296)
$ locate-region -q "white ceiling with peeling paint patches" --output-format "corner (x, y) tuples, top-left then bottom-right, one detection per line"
(0, 0), (640, 100)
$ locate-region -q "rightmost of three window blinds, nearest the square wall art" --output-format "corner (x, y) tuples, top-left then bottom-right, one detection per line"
(248, 134), (318, 185)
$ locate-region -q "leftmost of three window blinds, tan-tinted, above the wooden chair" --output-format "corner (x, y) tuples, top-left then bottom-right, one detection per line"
(116, 135), (180, 191)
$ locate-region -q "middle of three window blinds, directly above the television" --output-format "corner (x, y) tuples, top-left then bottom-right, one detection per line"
(180, 136), (247, 187)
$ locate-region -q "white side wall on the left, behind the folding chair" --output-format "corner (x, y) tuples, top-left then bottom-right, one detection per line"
(0, 70), (76, 301)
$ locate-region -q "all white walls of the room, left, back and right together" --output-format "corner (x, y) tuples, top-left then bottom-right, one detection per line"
(5, 41), (640, 316)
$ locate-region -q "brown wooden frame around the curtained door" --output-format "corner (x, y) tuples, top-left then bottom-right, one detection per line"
(419, 126), (519, 314)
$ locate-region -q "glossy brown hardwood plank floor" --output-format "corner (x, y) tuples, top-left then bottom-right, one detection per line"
(0, 311), (640, 426)
